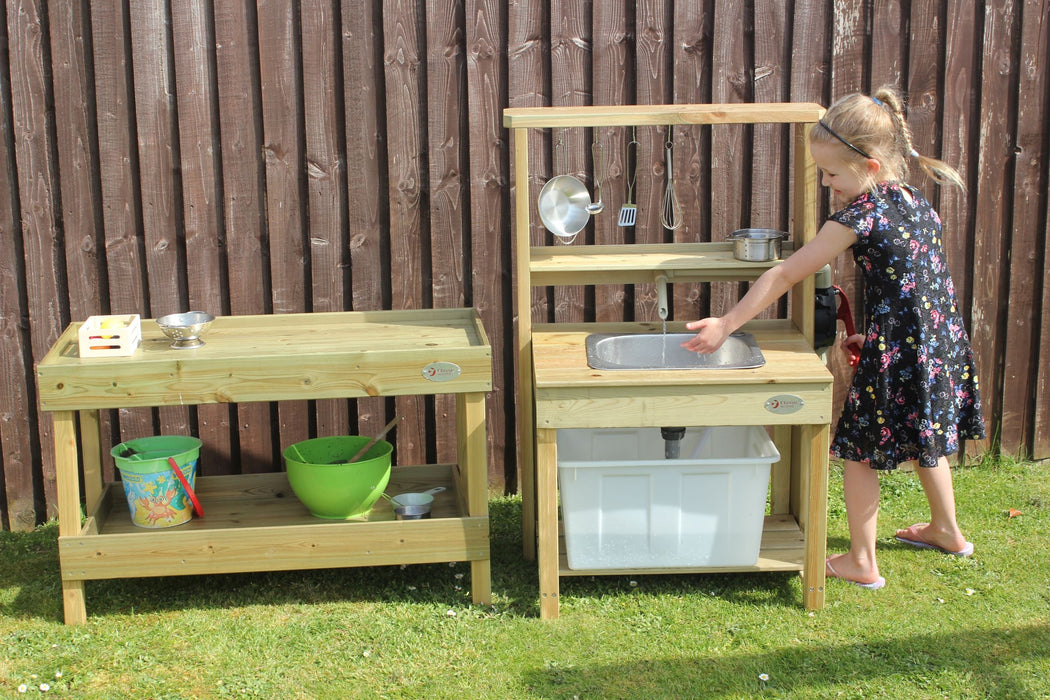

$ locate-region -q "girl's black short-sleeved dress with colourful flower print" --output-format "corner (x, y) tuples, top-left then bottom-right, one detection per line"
(831, 183), (985, 469)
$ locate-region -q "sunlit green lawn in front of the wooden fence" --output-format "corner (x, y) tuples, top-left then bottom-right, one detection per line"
(0, 463), (1050, 699)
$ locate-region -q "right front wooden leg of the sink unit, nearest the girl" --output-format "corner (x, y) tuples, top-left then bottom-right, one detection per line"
(799, 424), (832, 610)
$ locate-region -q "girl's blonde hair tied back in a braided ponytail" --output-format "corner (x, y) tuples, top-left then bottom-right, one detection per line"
(810, 85), (966, 189)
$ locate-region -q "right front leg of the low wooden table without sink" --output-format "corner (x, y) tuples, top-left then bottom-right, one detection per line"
(456, 391), (492, 603)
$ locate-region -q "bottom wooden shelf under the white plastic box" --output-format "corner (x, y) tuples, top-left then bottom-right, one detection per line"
(558, 515), (805, 576)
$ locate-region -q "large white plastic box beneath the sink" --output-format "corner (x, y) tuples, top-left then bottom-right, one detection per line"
(558, 426), (780, 569)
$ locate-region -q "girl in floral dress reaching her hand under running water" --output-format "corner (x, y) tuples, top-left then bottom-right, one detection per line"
(683, 87), (985, 589)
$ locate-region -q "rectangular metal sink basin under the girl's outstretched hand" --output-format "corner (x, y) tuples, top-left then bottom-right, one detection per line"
(587, 333), (765, 369)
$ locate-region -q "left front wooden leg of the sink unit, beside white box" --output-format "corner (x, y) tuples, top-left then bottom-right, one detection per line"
(536, 428), (559, 619)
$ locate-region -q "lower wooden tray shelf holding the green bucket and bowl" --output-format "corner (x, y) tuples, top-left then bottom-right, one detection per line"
(59, 465), (489, 583)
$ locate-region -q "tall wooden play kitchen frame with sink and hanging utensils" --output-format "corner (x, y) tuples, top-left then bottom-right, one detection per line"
(504, 104), (833, 618)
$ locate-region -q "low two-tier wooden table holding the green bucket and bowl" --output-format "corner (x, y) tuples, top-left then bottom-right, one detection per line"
(37, 309), (492, 623)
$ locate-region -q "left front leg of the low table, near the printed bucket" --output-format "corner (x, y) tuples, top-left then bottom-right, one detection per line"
(54, 410), (87, 624)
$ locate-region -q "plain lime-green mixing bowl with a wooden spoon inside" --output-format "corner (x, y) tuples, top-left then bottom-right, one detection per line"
(284, 436), (394, 521)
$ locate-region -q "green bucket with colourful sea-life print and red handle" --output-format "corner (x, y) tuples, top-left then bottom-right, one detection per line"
(109, 436), (203, 528)
